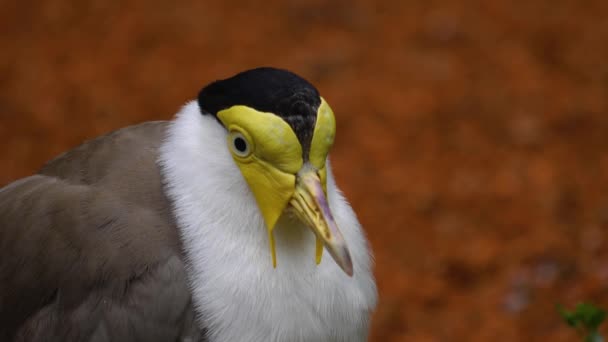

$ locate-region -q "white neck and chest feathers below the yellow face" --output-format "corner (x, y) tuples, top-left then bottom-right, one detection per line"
(160, 102), (377, 342)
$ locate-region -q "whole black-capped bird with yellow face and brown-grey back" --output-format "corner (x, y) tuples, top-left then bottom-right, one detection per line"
(0, 67), (378, 342)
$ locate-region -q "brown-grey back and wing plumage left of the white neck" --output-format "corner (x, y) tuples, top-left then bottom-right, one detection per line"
(0, 122), (204, 341)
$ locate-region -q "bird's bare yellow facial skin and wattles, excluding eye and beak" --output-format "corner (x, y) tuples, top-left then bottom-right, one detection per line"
(217, 99), (336, 267)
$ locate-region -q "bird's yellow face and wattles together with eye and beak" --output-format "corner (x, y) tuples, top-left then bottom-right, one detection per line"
(217, 99), (352, 275)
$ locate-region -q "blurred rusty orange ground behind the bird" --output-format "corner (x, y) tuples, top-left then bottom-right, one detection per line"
(0, 0), (608, 341)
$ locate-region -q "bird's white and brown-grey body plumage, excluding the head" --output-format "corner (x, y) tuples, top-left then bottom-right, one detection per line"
(0, 101), (377, 342)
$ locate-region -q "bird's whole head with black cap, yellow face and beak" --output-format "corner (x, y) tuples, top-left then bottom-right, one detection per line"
(198, 68), (353, 276)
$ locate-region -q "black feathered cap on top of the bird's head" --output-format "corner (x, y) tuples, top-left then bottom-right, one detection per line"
(198, 68), (321, 157)
